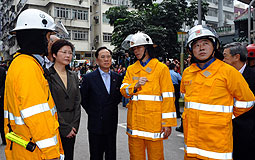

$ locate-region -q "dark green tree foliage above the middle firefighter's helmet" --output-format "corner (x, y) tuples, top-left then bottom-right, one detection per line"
(106, 0), (208, 57)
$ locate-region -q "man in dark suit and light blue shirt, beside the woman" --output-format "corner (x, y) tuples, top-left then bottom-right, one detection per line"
(81, 47), (122, 160)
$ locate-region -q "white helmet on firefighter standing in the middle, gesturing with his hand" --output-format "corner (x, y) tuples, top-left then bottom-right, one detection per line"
(130, 32), (153, 48)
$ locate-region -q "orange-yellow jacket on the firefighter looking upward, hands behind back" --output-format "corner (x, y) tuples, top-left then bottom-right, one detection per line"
(181, 59), (254, 160)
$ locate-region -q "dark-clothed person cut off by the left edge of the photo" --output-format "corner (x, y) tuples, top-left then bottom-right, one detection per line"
(0, 66), (6, 145)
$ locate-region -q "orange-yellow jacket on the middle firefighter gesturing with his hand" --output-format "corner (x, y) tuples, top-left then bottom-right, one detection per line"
(120, 59), (177, 141)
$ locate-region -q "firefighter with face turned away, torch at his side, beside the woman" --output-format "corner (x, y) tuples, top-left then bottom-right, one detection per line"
(4, 9), (64, 160)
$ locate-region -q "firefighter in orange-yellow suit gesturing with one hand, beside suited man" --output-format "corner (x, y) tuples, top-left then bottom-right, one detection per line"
(120, 32), (177, 160)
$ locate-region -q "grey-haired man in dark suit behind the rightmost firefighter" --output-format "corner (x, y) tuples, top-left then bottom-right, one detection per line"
(223, 42), (255, 160)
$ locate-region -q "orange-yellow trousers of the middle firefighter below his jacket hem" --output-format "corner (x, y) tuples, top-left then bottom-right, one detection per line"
(128, 136), (164, 160)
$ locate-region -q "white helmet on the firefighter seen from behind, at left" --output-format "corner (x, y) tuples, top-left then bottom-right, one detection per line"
(10, 9), (56, 34)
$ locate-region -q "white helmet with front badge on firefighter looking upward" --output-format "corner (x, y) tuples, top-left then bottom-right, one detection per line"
(187, 25), (220, 52)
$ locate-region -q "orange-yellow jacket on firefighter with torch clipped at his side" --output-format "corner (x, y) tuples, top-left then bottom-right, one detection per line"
(4, 53), (64, 160)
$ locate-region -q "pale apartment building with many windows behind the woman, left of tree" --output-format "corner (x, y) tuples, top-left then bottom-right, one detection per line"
(0, 0), (130, 62)
